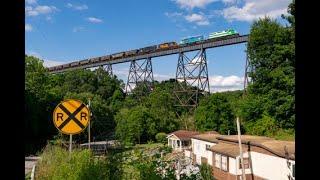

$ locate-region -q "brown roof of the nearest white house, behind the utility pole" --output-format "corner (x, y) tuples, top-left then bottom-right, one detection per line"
(210, 135), (295, 159)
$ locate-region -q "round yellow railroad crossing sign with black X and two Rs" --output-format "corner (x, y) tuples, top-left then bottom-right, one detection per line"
(53, 99), (90, 135)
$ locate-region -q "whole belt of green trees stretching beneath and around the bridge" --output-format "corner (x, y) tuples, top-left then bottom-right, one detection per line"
(25, 1), (295, 155)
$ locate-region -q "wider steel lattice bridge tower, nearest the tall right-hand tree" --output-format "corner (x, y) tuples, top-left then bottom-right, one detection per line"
(174, 48), (210, 110)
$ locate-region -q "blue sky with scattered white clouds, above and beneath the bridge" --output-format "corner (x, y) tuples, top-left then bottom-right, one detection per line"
(25, 0), (291, 92)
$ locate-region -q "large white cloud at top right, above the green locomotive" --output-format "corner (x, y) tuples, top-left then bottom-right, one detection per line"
(222, 0), (291, 22)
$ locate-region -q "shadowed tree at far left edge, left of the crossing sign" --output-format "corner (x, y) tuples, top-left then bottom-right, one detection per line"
(25, 56), (58, 154)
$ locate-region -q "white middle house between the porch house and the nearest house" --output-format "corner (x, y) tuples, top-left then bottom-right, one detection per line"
(185, 131), (220, 165)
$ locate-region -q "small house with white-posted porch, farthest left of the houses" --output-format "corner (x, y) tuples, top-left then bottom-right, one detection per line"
(167, 130), (199, 151)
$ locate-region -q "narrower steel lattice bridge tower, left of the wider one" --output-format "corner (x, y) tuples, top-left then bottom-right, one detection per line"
(126, 58), (154, 94)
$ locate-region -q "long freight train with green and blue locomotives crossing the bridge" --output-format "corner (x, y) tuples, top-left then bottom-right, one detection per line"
(49, 29), (239, 71)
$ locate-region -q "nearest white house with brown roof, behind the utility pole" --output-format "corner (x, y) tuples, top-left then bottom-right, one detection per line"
(210, 135), (295, 180)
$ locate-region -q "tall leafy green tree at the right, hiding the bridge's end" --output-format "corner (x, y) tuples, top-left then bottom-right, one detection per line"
(240, 1), (295, 132)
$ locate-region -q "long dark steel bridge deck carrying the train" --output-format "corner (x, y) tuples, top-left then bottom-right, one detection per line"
(50, 35), (249, 73)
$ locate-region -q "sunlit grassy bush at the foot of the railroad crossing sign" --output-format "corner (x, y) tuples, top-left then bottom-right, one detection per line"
(35, 145), (121, 180)
